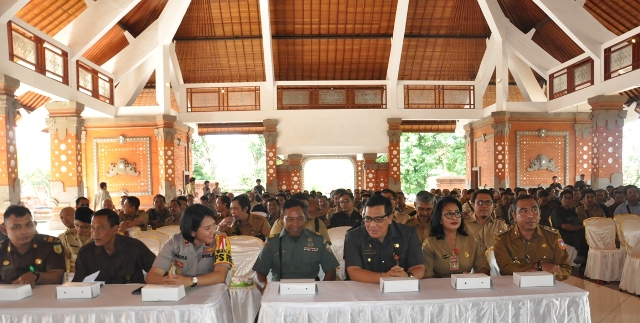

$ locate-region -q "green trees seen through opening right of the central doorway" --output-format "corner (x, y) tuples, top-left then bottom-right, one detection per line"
(400, 133), (466, 194)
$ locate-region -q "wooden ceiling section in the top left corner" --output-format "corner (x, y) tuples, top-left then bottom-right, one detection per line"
(15, 0), (87, 36)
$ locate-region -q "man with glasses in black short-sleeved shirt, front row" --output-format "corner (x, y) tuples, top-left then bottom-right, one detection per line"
(344, 195), (424, 283)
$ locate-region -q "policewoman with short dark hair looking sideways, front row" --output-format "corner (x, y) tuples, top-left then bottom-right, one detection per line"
(146, 204), (233, 287)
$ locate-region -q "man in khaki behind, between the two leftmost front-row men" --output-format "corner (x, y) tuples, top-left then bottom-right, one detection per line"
(59, 206), (93, 273)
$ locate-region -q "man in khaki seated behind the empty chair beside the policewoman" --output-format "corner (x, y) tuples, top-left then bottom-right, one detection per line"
(218, 194), (271, 241)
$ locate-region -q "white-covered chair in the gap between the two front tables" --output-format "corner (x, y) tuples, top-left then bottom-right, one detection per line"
(229, 236), (264, 323)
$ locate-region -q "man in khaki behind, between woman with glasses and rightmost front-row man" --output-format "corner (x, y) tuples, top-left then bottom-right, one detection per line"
(465, 189), (509, 249)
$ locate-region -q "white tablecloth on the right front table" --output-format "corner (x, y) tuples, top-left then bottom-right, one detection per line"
(259, 276), (591, 323)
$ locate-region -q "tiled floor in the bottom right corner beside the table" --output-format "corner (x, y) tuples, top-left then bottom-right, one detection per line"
(565, 276), (640, 323)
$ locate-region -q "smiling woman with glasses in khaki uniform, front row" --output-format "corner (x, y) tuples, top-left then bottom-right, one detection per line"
(422, 196), (489, 278)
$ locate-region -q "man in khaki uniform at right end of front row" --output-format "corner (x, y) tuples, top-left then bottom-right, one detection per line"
(493, 195), (571, 280)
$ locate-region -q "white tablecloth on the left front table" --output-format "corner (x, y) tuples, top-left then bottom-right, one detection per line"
(0, 284), (233, 323)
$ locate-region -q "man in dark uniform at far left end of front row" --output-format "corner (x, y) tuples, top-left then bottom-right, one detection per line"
(0, 205), (65, 286)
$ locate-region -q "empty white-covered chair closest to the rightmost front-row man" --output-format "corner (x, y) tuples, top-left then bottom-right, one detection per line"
(583, 218), (625, 282)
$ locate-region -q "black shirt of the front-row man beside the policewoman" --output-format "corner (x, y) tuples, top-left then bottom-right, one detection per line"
(73, 234), (156, 284)
